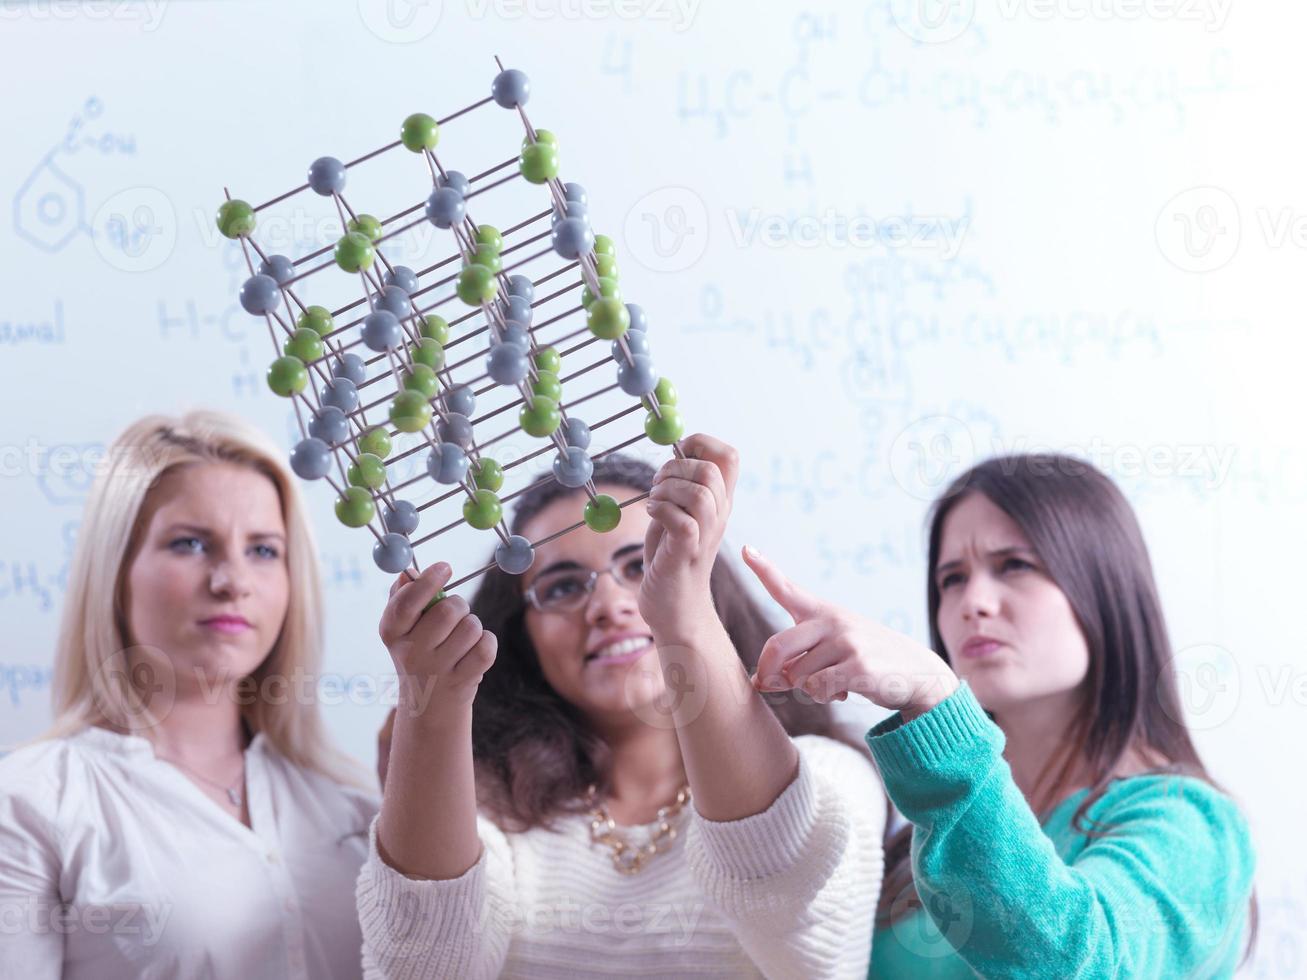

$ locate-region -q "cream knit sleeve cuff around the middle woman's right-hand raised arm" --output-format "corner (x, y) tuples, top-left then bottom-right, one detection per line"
(694, 753), (817, 881)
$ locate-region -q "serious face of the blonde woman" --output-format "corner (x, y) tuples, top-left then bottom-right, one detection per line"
(123, 463), (290, 694)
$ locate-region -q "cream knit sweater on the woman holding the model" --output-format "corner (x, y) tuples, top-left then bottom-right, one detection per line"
(357, 736), (885, 980)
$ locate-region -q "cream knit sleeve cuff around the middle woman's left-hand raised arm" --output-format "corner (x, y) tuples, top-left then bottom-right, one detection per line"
(357, 817), (488, 950)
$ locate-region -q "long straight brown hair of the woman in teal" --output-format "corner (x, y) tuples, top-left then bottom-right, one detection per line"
(877, 453), (1257, 951)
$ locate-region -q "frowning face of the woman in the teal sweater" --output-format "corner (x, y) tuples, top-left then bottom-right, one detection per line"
(933, 493), (1089, 713)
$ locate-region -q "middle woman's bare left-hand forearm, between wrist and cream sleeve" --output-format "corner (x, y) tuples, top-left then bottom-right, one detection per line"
(376, 704), (481, 879)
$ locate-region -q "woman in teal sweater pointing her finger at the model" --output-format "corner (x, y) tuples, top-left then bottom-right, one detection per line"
(745, 455), (1256, 977)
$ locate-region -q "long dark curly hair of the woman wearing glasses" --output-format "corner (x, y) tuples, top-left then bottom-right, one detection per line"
(471, 455), (870, 831)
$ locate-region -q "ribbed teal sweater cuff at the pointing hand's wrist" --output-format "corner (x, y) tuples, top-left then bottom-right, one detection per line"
(867, 681), (1004, 780)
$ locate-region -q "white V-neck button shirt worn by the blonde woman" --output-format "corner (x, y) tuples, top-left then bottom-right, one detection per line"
(0, 728), (378, 980)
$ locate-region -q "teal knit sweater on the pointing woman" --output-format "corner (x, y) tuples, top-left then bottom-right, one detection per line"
(867, 682), (1253, 980)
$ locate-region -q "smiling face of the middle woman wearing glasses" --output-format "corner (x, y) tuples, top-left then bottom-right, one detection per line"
(521, 486), (663, 724)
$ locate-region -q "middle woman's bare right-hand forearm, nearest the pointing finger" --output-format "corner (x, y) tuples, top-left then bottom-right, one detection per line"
(654, 613), (799, 821)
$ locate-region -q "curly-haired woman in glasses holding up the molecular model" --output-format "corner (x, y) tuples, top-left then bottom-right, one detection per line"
(358, 436), (886, 980)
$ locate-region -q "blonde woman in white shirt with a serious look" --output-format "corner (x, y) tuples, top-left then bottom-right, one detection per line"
(0, 412), (378, 980)
